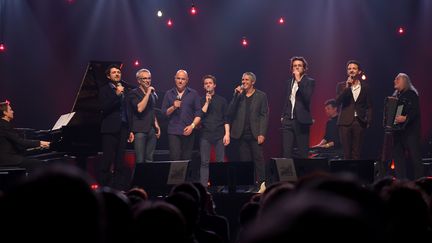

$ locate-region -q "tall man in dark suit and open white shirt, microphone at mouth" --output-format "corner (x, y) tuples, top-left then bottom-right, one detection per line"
(281, 57), (315, 158)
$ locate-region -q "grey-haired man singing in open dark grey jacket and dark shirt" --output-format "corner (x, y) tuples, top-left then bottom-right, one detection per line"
(228, 72), (269, 185)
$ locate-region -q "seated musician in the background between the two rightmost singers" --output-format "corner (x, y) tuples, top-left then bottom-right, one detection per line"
(310, 99), (342, 159)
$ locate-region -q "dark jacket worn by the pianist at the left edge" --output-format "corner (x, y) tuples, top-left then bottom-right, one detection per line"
(0, 119), (40, 166)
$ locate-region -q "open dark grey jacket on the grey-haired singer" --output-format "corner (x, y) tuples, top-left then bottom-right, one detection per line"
(228, 89), (269, 139)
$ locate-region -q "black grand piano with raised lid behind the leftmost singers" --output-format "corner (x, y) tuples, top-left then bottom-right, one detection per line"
(21, 61), (169, 170)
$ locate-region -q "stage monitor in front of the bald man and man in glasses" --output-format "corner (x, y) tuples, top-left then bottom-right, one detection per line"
(132, 160), (190, 197)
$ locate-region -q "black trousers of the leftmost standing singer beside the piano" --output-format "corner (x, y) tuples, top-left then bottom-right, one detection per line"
(96, 127), (132, 191)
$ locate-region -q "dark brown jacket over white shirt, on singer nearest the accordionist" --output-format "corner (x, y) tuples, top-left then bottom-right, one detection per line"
(336, 82), (372, 127)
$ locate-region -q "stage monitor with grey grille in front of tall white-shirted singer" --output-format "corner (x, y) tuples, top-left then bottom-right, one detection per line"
(266, 158), (330, 185)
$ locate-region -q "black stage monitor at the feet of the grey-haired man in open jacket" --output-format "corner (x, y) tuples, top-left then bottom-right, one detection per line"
(209, 161), (255, 188)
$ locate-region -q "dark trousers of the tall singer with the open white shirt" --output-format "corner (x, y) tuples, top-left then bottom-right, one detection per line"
(282, 118), (310, 158)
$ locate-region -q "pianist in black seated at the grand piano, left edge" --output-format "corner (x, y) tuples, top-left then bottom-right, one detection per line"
(0, 101), (50, 172)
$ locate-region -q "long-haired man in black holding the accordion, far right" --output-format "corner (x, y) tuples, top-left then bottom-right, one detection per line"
(393, 73), (424, 180)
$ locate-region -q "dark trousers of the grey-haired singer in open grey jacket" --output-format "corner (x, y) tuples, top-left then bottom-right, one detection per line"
(238, 136), (265, 185)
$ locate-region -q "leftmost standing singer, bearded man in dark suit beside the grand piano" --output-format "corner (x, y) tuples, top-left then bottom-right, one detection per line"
(96, 65), (133, 190)
